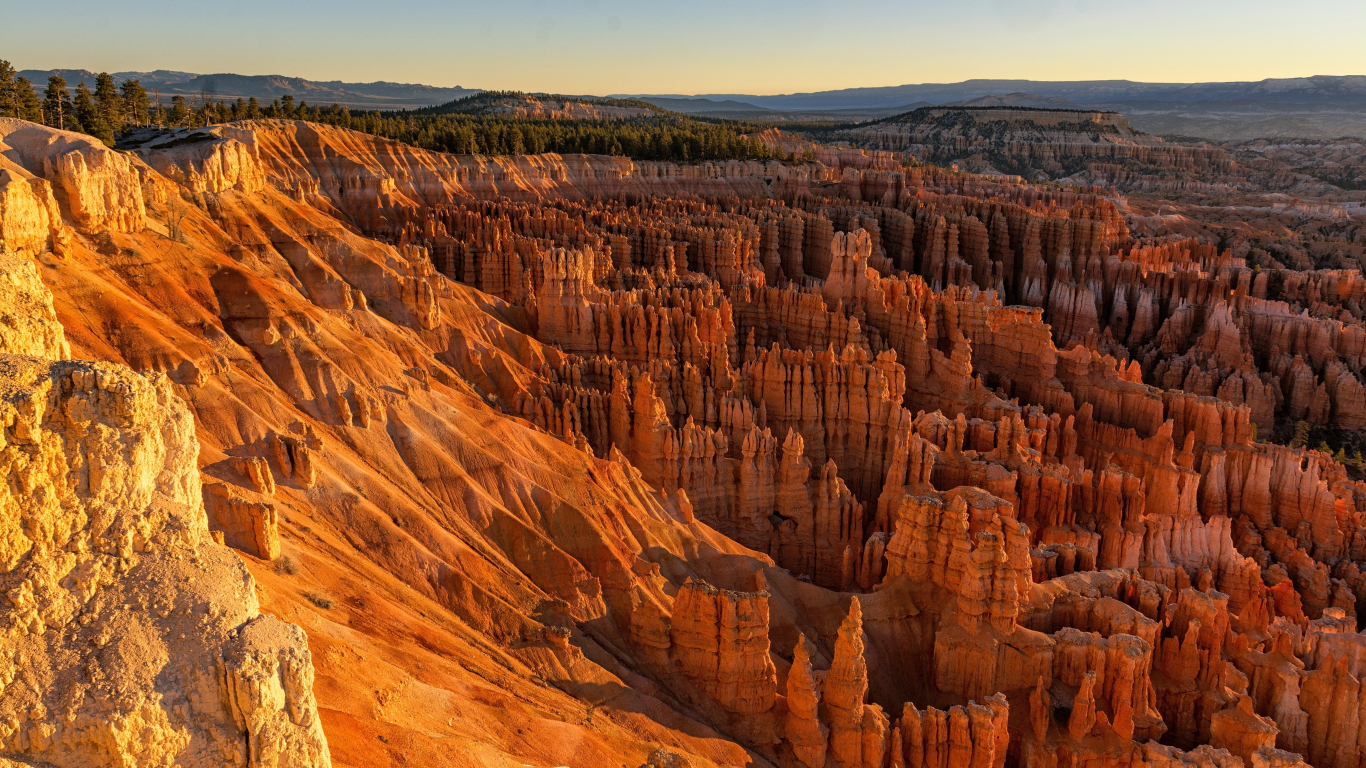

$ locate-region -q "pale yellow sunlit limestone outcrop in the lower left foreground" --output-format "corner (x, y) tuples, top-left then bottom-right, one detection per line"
(0, 256), (331, 768)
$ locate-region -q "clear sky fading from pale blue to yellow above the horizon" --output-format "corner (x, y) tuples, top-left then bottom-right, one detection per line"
(0, 0), (1366, 96)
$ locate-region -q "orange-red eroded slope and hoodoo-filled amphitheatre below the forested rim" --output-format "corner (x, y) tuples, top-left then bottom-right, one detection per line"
(0, 113), (1366, 768)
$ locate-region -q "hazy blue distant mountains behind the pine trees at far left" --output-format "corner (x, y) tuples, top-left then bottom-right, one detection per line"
(19, 70), (479, 109)
